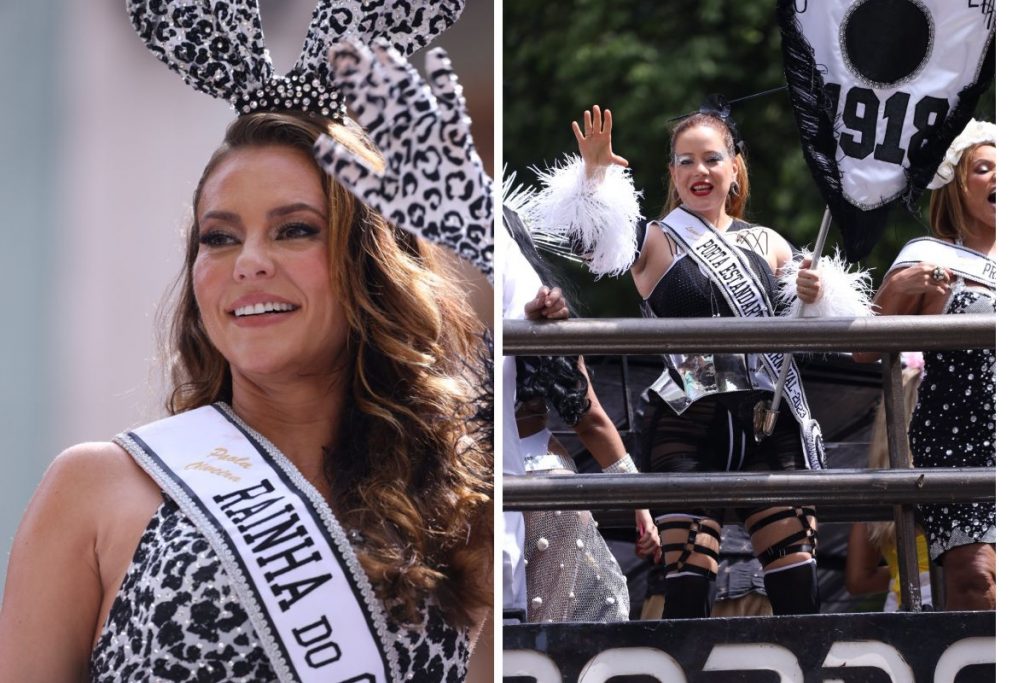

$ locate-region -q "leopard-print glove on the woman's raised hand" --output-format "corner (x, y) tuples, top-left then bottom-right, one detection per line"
(314, 39), (494, 282)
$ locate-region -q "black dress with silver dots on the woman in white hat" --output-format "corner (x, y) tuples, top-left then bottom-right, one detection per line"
(909, 281), (995, 560)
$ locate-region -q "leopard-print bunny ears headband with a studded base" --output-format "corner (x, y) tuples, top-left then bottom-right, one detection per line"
(128, 0), (465, 122)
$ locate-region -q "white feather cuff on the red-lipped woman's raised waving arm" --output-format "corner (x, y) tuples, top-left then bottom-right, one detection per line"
(526, 155), (641, 278)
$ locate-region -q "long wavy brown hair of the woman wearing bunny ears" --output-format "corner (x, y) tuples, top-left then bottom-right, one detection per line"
(167, 113), (494, 626)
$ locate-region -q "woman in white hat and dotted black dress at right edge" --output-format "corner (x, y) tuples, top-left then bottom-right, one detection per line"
(858, 121), (995, 609)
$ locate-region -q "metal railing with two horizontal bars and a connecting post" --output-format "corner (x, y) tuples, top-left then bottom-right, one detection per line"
(503, 314), (995, 611)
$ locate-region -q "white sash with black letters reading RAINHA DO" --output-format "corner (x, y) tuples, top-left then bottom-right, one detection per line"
(115, 403), (397, 683)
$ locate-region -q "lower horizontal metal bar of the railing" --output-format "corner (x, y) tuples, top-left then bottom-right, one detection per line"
(503, 467), (995, 510)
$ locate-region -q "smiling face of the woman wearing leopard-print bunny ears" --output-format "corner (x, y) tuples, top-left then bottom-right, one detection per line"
(193, 145), (348, 379)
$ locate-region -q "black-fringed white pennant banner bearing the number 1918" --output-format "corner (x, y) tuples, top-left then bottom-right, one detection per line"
(777, 0), (995, 260)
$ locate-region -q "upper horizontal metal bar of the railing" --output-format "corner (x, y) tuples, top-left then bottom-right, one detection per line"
(502, 314), (995, 355)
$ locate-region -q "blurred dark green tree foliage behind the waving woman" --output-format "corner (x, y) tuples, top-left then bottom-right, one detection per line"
(503, 0), (995, 316)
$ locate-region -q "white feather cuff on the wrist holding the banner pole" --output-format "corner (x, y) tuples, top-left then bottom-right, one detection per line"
(778, 248), (874, 317)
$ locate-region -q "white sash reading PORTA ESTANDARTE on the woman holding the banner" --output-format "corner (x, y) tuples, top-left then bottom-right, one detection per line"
(657, 207), (824, 470)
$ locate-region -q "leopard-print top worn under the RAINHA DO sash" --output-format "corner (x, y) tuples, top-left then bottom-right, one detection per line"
(89, 498), (469, 683)
